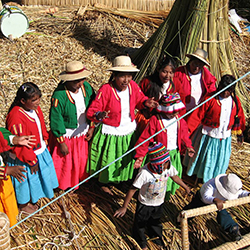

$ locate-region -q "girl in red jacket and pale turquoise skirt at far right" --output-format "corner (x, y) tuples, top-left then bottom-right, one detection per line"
(183, 75), (245, 182)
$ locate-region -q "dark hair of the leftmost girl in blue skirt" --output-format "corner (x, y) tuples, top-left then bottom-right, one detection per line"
(8, 82), (42, 113)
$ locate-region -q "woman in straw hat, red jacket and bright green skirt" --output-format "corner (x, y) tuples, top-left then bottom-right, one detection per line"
(87, 56), (158, 194)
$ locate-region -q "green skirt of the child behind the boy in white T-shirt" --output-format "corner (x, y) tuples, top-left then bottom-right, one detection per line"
(165, 149), (182, 200)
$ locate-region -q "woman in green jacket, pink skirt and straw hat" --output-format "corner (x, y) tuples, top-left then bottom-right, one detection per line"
(49, 61), (94, 190)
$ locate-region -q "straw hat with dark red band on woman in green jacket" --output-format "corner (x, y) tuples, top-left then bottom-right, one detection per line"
(59, 61), (92, 81)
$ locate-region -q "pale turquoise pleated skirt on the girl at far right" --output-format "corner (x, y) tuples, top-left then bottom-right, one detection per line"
(184, 129), (231, 183)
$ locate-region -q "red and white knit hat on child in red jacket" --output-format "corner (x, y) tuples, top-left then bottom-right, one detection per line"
(156, 93), (185, 114)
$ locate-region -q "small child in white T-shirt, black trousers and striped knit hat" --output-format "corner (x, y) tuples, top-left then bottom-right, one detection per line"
(114, 143), (190, 249)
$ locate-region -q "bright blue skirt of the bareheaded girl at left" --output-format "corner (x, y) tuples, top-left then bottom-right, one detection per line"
(7, 148), (58, 204)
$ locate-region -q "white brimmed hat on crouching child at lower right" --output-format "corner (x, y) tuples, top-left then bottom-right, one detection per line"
(215, 174), (242, 200)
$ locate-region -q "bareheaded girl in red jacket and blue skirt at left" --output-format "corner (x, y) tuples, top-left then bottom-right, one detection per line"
(6, 82), (58, 213)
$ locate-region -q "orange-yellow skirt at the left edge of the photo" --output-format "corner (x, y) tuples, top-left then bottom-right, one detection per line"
(0, 176), (18, 227)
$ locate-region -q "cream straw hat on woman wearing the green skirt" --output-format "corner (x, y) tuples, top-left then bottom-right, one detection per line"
(107, 56), (140, 72)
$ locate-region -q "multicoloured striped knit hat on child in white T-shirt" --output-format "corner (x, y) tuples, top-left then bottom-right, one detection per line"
(148, 142), (170, 174)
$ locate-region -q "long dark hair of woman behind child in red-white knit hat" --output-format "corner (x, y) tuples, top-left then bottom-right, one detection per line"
(144, 57), (176, 100)
